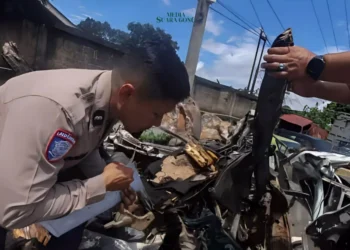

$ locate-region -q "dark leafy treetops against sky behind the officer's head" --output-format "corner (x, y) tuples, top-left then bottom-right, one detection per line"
(78, 18), (180, 50)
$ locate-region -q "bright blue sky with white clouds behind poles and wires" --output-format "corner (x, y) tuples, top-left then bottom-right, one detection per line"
(52, 0), (350, 109)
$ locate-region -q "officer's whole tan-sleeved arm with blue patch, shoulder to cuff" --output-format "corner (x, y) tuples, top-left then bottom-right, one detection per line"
(0, 97), (106, 228)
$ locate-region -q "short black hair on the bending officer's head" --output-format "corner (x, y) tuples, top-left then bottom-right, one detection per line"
(116, 41), (190, 102)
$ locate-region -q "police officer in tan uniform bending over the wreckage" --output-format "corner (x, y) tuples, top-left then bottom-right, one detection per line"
(0, 43), (189, 249)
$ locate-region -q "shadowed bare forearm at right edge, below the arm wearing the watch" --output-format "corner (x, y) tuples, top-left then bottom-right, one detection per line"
(309, 81), (350, 104)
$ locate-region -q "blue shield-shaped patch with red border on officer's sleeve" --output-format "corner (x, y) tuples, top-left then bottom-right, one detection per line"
(45, 129), (76, 162)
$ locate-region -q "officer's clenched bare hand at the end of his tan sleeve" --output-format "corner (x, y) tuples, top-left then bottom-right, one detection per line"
(103, 162), (134, 191)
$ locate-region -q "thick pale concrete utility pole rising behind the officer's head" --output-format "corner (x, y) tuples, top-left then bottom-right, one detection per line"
(185, 0), (216, 97)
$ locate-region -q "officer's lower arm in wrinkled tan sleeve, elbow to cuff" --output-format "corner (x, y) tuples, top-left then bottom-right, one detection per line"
(1, 175), (106, 229)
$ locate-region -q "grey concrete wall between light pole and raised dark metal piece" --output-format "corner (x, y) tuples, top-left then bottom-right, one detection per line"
(194, 77), (256, 118)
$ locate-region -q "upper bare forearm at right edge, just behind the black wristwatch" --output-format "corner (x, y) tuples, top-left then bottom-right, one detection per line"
(320, 52), (350, 83)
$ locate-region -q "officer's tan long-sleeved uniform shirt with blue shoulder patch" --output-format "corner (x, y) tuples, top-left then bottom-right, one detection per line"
(0, 69), (115, 228)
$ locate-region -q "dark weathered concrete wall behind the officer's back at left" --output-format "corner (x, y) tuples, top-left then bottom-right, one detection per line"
(0, 20), (121, 85)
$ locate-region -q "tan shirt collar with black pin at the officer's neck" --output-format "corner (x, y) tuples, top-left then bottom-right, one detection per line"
(89, 71), (112, 131)
